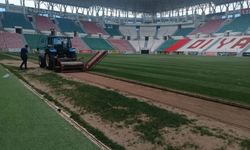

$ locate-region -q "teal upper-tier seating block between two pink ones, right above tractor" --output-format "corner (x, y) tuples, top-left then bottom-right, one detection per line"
(56, 18), (85, 33)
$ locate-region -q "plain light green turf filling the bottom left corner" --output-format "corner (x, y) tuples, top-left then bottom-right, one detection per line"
(0, 65), (100, 150)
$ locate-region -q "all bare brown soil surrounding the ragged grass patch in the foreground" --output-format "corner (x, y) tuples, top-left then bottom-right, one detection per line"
(1, 61), (250, 150)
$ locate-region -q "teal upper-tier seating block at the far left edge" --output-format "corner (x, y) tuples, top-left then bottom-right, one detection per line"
(1, 12), (34, 30)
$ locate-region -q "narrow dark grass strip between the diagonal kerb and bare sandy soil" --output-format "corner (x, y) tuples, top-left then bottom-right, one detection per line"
(0, 63), (125, 150)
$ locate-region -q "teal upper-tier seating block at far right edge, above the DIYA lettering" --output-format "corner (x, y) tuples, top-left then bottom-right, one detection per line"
(216, 14), (250, 33)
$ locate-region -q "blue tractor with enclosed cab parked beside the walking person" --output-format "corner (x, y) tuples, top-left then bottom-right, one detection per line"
(37, 35), (84, 72)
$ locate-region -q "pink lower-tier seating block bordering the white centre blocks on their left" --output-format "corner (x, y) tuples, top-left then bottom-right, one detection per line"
(107, 39), (134, 52)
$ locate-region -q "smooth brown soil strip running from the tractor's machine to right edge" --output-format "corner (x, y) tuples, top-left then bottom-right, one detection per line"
(65, 72), (250, 130)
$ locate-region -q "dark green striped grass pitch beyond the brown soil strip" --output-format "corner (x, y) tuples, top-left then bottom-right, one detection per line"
(4, 54), (250, 105)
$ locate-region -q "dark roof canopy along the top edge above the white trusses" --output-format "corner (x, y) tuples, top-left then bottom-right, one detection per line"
(40, 0), (242, 14)
